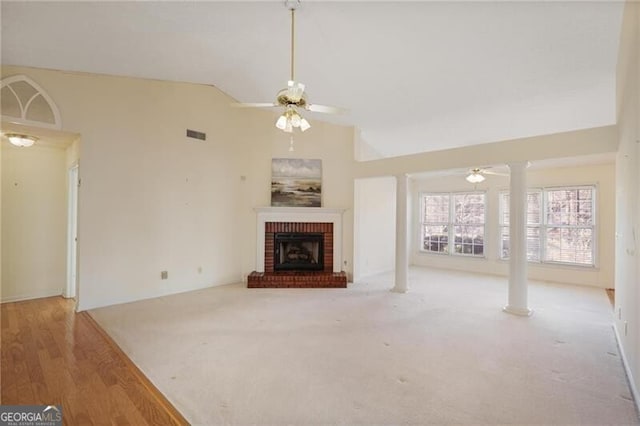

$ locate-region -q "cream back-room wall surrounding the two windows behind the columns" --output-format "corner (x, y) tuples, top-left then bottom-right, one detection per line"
(411, 164), (615, 288)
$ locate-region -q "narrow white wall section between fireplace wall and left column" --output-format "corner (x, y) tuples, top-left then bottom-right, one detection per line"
(354, 176), (396, 281)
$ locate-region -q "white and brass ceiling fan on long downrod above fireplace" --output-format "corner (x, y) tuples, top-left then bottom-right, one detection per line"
(234, 0), (344, 133)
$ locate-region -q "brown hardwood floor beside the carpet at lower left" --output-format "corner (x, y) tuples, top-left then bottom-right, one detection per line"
(0, 297), (188, 425)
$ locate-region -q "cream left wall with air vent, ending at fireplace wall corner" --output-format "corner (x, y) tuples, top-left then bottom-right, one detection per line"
(3, 67), (248, 310)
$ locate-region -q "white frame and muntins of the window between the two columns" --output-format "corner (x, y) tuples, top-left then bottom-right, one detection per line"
(418, 191), (488, 259)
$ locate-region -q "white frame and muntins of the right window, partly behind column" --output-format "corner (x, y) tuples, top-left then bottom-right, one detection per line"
(498, 184), (599, 269)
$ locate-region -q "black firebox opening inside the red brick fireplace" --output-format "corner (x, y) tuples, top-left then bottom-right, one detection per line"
(273, 232), (324, 271)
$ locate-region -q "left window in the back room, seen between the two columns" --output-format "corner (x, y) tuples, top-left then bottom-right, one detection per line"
(421, 192), (485, 256)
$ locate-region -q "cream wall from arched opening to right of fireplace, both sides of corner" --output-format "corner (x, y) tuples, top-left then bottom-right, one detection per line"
(2, 66), (353, 310)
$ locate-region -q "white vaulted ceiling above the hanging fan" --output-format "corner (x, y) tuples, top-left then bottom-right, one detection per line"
(1, 0), (624, 156)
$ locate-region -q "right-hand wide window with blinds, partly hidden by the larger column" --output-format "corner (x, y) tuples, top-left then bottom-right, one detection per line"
(500, 186), (596, 266)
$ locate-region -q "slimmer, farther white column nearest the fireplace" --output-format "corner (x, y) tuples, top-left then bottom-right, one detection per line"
(391, 174), (409, 293)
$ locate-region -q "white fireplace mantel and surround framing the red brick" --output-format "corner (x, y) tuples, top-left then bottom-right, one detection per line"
(254, 207), (346, 272)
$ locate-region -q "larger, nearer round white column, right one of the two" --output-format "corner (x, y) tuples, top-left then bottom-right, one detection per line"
(503, 162), (532, 316)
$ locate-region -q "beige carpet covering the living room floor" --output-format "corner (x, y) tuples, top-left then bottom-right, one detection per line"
(91, 268), (638, 425)
